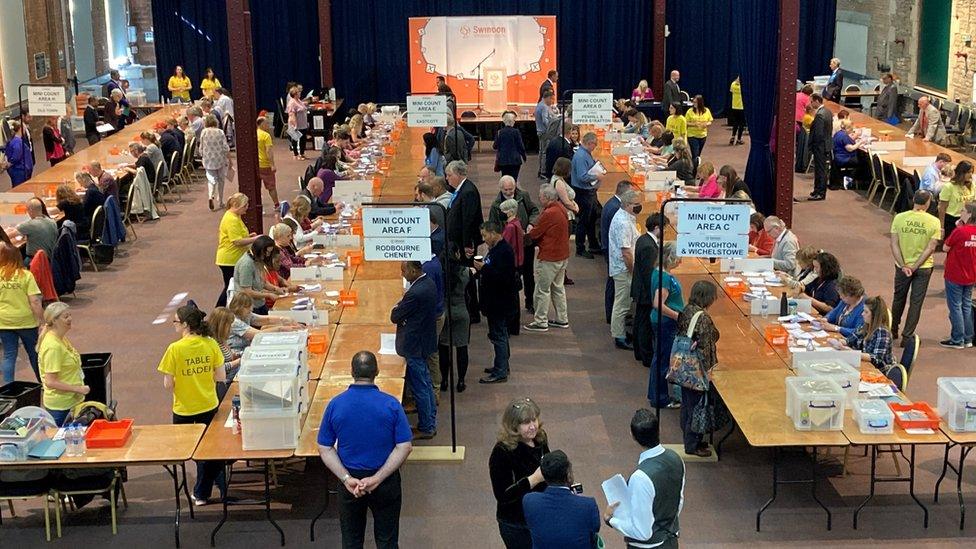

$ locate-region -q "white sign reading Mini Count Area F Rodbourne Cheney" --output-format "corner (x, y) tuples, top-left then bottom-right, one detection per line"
(363, 207), (431, 261)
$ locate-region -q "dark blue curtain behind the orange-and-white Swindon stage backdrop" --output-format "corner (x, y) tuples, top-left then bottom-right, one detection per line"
(332, 0), (653, 110)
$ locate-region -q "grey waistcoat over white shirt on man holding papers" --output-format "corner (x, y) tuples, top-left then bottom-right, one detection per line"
(624, 449), (685, 546)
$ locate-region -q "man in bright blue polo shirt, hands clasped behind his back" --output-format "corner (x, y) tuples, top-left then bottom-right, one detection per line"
(318, 351), (413, 549)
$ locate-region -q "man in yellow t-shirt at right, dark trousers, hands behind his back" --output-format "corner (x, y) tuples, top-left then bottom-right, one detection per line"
(891, 190), (942, 346)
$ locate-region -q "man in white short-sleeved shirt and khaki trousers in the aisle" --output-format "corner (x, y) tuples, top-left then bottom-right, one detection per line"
(607, 189), (644, 350)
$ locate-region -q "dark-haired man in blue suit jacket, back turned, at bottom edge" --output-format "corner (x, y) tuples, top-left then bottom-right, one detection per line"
(522, 450), (600, 549)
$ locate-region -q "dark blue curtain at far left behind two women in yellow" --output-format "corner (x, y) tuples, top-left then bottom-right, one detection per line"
(152, 0), (232, 99)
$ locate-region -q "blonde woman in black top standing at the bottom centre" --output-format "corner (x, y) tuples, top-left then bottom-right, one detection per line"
(488, 398), (549, 549)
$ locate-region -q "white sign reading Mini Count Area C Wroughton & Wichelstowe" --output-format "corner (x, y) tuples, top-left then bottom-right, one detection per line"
(677, 202), (751, 257)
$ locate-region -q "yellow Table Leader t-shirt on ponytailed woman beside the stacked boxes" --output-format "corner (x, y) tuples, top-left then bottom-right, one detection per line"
(157, 335), (224, 416)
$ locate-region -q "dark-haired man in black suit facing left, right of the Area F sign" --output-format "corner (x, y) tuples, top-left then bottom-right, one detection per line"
(474, 221), (518, 383)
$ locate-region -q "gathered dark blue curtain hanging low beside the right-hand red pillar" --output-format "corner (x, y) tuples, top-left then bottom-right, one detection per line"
(732, 0), (776, 215)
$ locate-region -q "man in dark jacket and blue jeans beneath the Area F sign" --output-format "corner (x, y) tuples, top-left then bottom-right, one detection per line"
(390, 261), (437, 440)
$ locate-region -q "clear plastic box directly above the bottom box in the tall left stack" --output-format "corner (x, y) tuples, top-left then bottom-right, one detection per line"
(237, 351), (307, 411)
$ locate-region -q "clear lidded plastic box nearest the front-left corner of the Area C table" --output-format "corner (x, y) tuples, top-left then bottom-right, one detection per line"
(786, 376), (847, 431)
